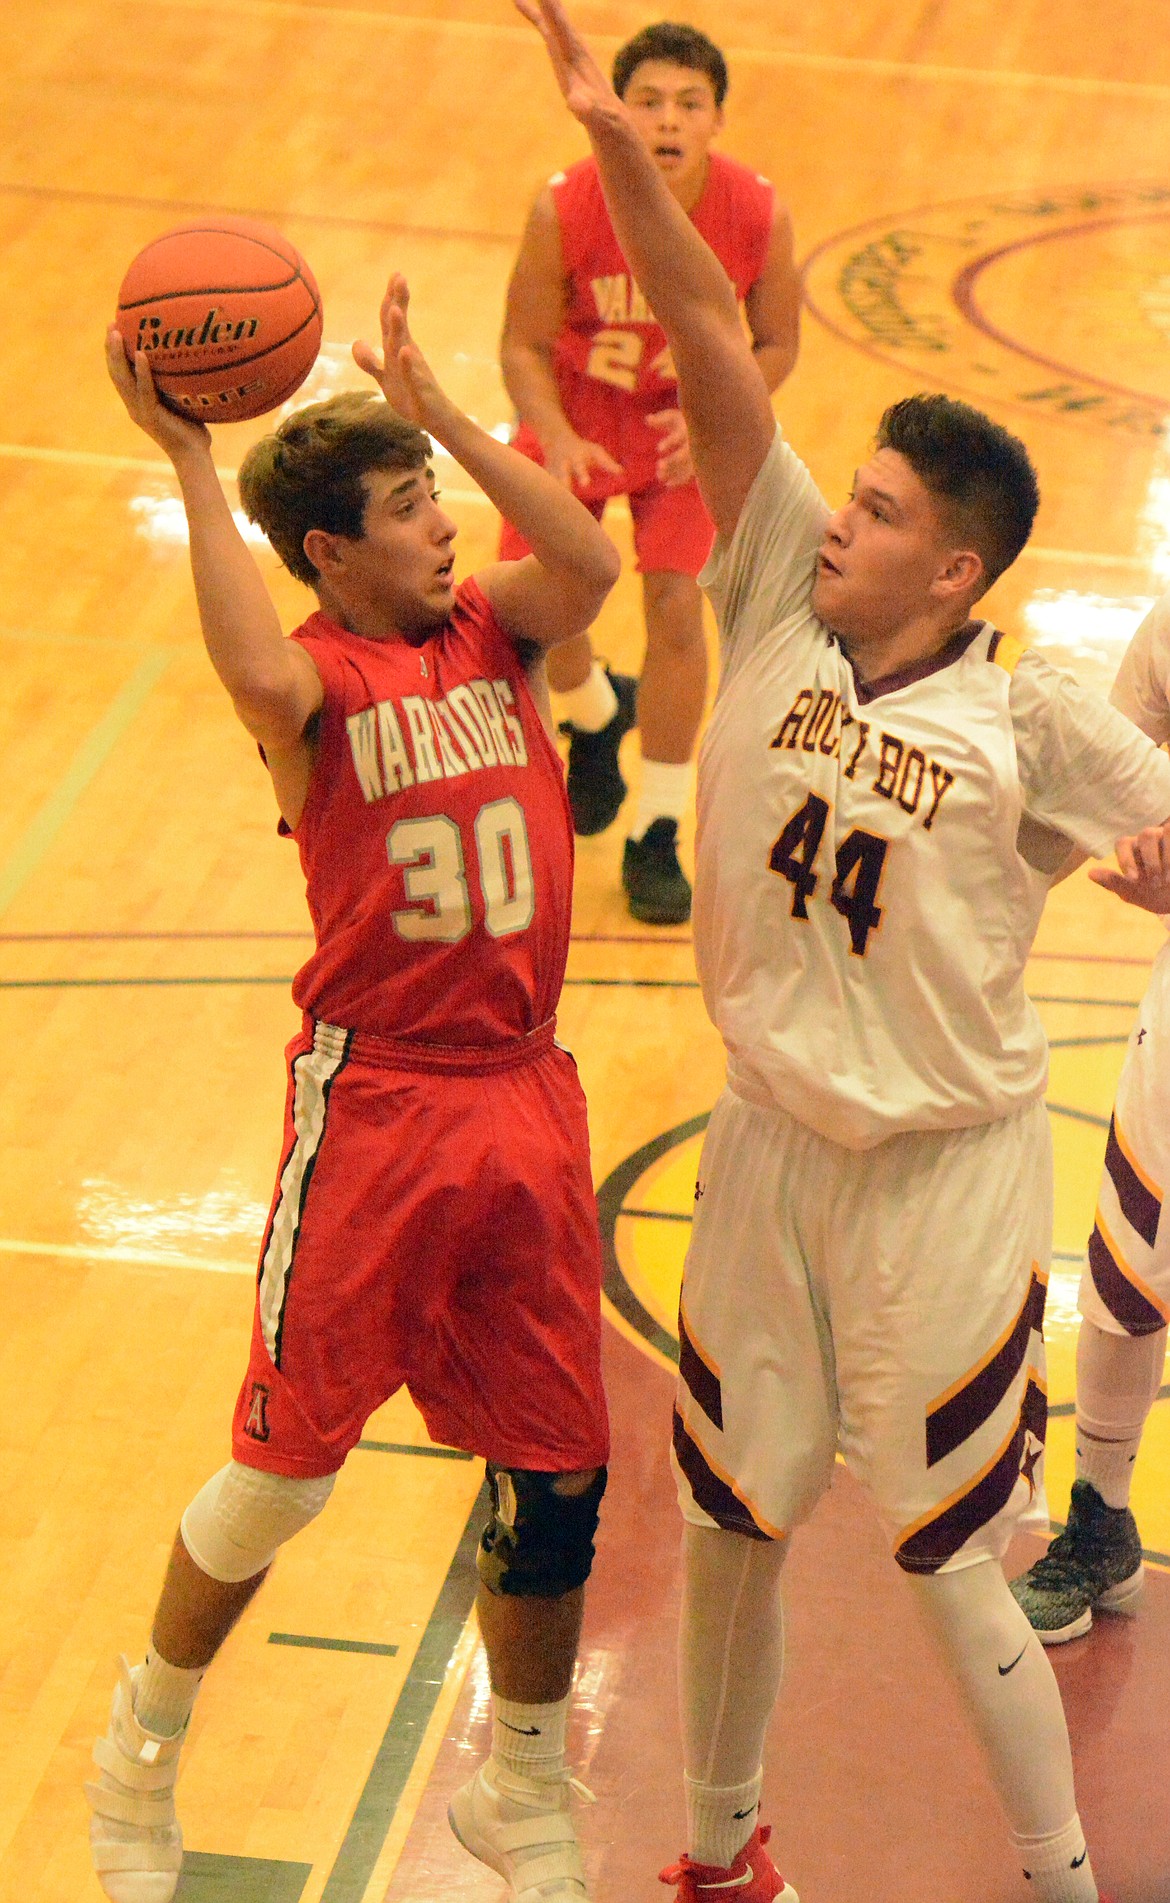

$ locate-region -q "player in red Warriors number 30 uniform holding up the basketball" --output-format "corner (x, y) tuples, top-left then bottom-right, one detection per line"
(88, 278), (618, 1903)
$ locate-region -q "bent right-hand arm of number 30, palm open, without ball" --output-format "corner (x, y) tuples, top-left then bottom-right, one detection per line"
(354, 276), (620, 647)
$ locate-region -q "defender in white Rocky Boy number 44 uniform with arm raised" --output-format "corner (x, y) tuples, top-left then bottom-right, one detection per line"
(517, 0), (1170, 1903)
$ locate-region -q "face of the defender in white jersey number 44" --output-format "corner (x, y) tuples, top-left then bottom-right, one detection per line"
(812, 449), (955, 653)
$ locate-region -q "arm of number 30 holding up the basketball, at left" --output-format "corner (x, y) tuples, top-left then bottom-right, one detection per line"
(107, 329), (323, 761)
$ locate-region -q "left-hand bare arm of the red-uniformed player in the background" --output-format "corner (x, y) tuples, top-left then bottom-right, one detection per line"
(500, 186), (620, 487)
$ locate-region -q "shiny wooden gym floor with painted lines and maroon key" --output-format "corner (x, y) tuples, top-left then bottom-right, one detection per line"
(0, 0), (1170, 1903)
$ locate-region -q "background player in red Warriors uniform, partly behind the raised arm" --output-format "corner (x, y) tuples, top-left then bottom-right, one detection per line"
(500, 23), (801, 923)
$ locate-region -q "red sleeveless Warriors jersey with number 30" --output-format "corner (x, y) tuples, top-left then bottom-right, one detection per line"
(282, 580), (573, 1045)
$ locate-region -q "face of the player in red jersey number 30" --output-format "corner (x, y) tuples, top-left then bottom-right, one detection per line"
(346, 468), (457, 634)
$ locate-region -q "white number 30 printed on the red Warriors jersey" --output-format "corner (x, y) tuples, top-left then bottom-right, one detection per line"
(386, 799), (536, 944)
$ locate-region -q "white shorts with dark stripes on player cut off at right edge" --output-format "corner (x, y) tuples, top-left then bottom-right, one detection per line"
(1079, 940), (1170, 1334)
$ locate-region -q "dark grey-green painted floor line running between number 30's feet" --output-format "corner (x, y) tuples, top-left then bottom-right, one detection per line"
(322, 1481), (489, 1903)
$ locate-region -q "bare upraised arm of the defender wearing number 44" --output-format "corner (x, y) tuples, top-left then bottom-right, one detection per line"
(516, 0), (776, 535)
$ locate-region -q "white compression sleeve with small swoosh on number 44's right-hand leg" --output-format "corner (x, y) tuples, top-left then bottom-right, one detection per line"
(913, 1560), (1098, 1903)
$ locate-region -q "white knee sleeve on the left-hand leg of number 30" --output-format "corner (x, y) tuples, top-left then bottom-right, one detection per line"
(181, 1460), (337, 1585)
